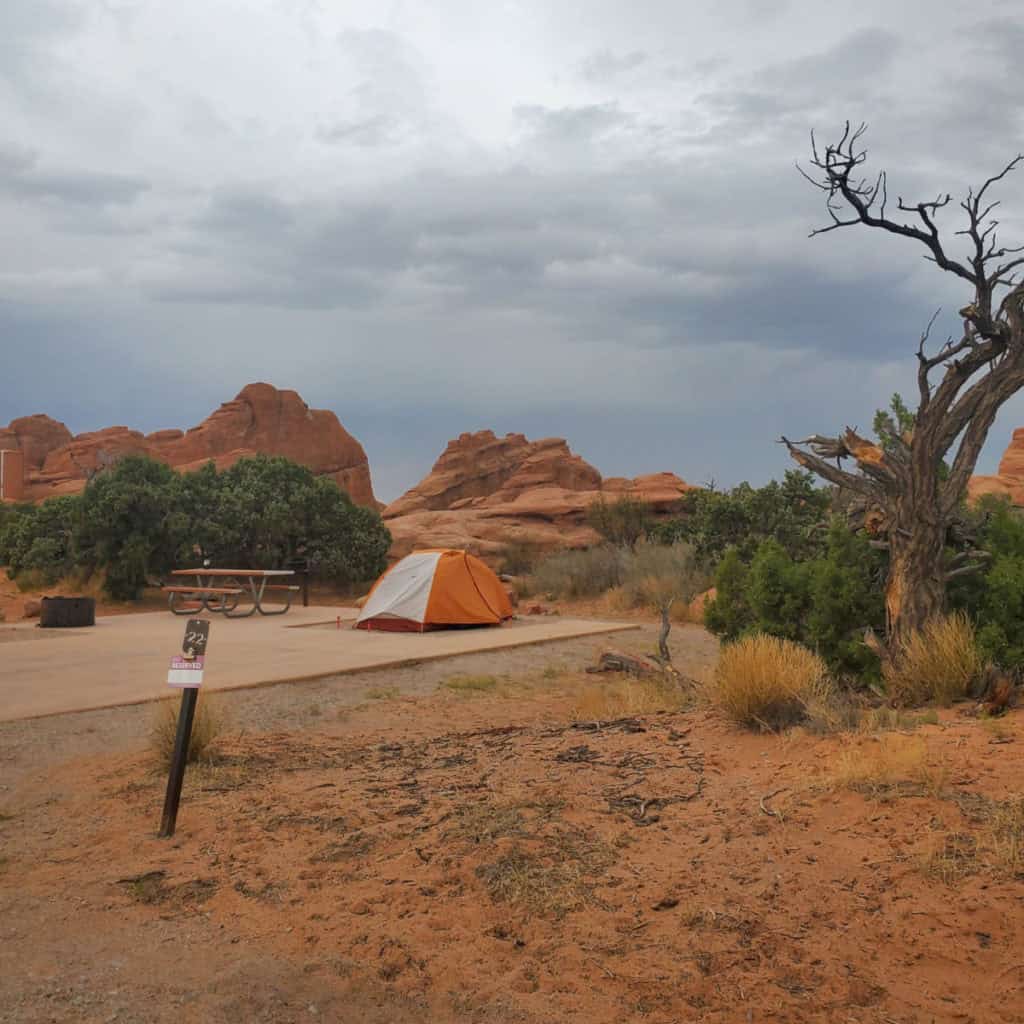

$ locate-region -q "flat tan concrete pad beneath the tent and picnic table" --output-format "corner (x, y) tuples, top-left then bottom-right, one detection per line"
(0, 608), (635, 721)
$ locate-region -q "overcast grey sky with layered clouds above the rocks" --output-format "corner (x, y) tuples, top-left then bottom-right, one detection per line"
(0, 0), (1024, 500)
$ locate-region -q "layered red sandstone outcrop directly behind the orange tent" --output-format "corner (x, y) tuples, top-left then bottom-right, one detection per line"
(384, 430), (690, 557)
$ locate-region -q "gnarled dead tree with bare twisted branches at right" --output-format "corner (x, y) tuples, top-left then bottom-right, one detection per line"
(782, 123), (1024, 650)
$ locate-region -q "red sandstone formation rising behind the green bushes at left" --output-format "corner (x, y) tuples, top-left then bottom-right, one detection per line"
(0, 384), (378, 507)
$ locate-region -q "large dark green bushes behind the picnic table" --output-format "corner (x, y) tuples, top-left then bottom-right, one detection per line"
(0, 456), (391, 600)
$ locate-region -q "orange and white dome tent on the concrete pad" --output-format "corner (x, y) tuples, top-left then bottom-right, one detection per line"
(355, 549), (512, 633)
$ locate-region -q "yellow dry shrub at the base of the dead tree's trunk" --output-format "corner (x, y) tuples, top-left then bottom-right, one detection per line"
(883, 611), (985, 708)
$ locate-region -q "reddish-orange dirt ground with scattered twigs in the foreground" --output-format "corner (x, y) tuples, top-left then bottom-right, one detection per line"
(0, 627), (1024, 1024)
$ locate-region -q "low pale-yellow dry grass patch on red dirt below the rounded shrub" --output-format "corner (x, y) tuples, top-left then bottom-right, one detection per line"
(830, 734), (949, 797)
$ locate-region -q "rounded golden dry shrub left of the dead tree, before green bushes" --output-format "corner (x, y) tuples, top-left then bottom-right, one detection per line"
(708, 633), (831, 729)
